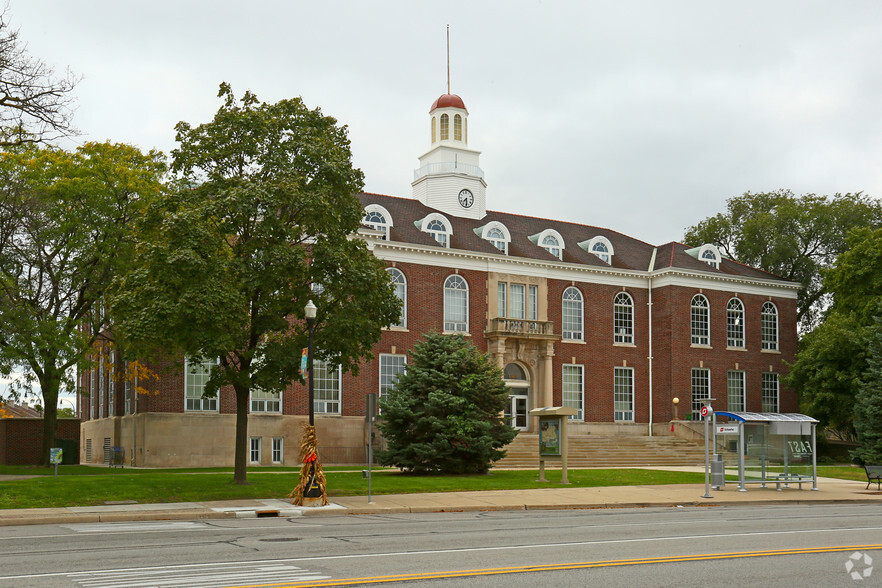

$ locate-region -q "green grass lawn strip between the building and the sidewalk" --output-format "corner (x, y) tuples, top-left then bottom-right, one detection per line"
(0, 466), (866, 508)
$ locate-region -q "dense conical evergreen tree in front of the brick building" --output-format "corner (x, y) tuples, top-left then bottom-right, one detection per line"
(377, 333), (517, 474)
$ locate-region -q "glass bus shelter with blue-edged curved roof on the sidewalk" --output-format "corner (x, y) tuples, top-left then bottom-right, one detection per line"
(713, 410), (818, 492)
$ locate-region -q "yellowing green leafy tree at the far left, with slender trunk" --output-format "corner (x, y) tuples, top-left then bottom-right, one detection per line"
(0, 143), (165, 463)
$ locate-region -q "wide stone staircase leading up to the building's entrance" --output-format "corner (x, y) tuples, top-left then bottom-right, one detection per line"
(494, 432), (704, 468)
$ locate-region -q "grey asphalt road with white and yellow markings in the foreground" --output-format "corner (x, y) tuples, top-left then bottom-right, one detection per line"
(0, 504), (882, 588)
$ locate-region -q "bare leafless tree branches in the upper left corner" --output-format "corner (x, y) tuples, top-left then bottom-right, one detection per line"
(0, 9), (77, 147)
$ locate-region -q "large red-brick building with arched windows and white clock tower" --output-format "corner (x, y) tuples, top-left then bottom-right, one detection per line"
(79, 94), (799, 466)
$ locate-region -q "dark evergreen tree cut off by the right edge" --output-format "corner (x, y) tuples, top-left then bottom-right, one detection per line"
(851, 317), (882, 465)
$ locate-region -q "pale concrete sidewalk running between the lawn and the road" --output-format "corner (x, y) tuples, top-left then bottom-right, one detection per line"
(0, 478), (882, 526)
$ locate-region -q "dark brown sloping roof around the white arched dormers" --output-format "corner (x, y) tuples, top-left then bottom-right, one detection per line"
(359, 193), (786, 282)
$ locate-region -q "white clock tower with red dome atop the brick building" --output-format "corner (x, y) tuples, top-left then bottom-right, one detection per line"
(411, 94), (487, 219)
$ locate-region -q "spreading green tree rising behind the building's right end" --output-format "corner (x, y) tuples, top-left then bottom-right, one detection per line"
(684, 190), (882, 332)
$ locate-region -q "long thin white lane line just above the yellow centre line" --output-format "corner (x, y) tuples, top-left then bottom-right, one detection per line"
(0, 527), (882, 580)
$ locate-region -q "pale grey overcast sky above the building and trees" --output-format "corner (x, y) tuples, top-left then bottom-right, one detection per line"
(8, 0), (882, 244)
